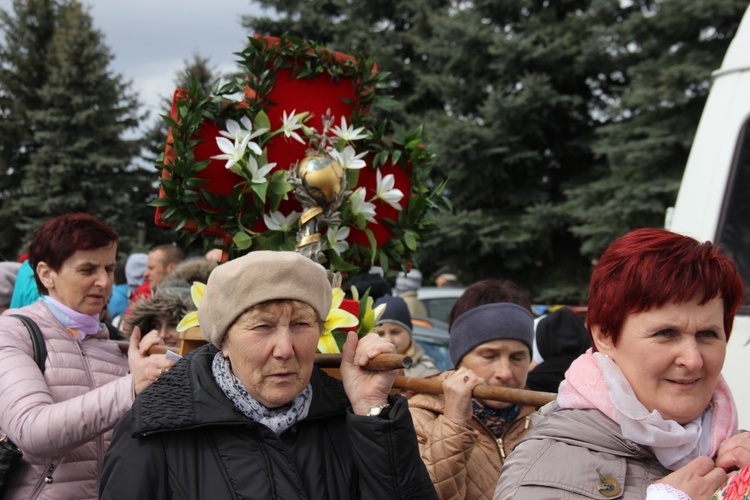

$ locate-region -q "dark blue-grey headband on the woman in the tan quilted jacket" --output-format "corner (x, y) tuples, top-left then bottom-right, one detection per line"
(449, 302), (534, 367)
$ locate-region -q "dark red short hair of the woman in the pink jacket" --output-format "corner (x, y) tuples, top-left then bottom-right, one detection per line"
(29, 213), (120, 295)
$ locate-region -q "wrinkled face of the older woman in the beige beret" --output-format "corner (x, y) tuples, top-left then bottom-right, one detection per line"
(221, 301), (321, 408)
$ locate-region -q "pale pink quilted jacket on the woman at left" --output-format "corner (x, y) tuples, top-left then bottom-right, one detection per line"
(0, 300), (135, 500)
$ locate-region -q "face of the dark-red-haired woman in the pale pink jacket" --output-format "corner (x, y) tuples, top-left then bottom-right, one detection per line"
(36, 243), (117, 314)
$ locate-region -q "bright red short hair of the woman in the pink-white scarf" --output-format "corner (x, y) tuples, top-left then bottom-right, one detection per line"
(587, 229), (745, 350)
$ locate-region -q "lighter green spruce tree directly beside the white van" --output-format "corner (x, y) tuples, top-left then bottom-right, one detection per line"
(556, 0), (748, 258)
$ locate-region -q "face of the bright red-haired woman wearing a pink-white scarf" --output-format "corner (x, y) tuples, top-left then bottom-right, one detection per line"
(592, 298), (727, 424)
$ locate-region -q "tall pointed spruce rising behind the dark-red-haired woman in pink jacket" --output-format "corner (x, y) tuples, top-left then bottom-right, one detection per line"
(13, 1), (144, 246)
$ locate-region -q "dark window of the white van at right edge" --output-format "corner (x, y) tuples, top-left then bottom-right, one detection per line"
(716, 118), (750, 312)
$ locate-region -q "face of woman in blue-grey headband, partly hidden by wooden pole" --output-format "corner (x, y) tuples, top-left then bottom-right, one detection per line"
(458, 339), (531, 409)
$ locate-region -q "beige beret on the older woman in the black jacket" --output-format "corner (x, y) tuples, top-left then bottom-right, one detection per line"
(198, 251), (333, 349)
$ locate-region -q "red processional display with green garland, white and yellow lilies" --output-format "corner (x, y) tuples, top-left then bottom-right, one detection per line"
(152, 35), (449, 352)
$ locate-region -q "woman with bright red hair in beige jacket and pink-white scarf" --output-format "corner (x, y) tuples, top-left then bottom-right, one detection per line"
(495, 229), (750, 500)
